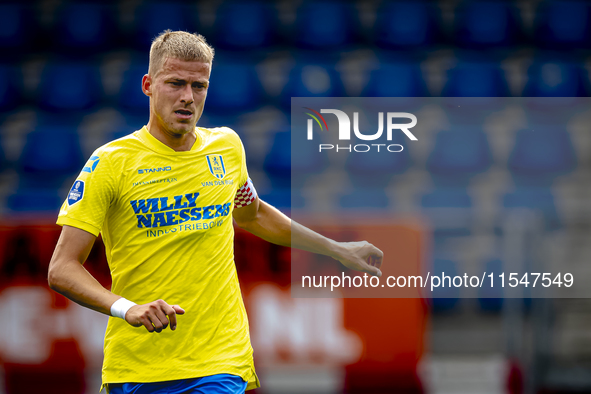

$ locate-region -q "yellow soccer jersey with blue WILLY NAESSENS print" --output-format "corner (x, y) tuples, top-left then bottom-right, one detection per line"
(57, 127), (259, 390)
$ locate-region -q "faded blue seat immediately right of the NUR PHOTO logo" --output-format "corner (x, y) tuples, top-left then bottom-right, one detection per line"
(427, 126), (492, 186)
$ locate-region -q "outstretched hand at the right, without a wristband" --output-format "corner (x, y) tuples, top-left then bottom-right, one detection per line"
(333, 241), (384, 277)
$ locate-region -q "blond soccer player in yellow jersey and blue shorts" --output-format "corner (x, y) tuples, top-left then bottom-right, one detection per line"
(48, 31), (382, 394)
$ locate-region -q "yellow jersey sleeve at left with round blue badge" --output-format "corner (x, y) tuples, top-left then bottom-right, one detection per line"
(57, 149), (117, 236)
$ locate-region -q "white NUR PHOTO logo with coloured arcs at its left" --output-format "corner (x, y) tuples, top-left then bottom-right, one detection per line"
(304, 107), (417, 152)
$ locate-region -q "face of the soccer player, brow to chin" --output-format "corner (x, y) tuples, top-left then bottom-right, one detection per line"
(142, 58), (211, 135)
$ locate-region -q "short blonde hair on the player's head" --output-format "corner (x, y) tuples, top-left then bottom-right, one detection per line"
(148, 30), (214, 77)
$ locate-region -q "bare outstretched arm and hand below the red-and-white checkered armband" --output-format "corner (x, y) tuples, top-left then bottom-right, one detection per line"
(233, 197), (384, 276)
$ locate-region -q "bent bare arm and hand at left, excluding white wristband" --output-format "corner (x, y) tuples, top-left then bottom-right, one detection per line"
(48, 226), (185, 332)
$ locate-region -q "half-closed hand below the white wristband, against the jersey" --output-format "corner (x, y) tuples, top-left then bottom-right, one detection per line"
(125, 300), (185, 332)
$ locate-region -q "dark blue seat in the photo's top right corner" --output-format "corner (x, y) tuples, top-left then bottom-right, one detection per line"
(535, 0), (591, 49)
